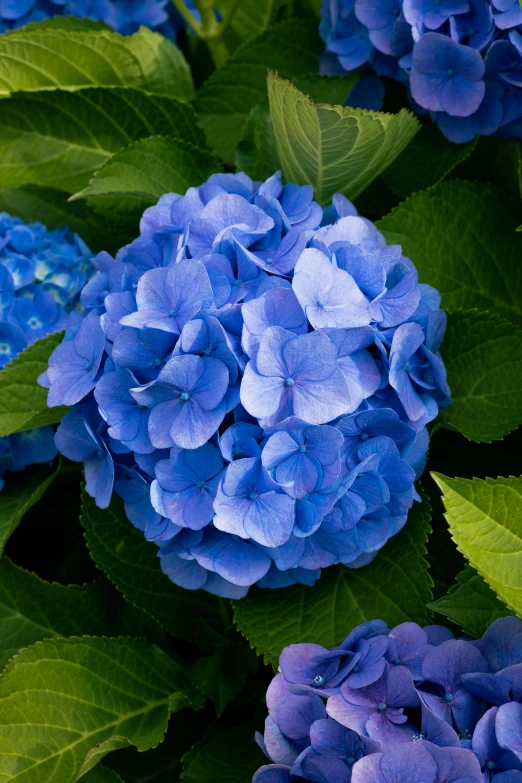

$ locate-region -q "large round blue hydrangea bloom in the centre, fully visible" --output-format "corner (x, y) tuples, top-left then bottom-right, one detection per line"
(41, 173), (449, 597)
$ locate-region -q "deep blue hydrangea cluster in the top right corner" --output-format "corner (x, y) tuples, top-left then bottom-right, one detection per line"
(320, 0), (522, 143)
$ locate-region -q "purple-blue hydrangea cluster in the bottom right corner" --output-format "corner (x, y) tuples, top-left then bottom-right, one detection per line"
(253, 617), (522, 783)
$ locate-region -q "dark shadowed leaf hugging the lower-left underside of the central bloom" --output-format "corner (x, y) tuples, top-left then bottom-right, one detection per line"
(81, 492), (221, 641)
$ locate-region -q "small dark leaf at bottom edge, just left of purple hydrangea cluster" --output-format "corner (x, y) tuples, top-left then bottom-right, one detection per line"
(180, 725), (266, 783)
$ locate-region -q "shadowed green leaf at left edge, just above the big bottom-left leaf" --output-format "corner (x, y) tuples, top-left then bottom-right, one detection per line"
(0, 557), (109, 670)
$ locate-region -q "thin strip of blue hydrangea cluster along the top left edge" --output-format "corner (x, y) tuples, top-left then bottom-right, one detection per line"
(0, 0), (197, 40)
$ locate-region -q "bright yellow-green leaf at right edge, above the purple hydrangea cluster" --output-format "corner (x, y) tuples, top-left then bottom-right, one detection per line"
(433, 473), (522, 614)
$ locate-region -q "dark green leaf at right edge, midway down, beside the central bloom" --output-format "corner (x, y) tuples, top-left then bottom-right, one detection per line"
(437, 310), (522, 443)
